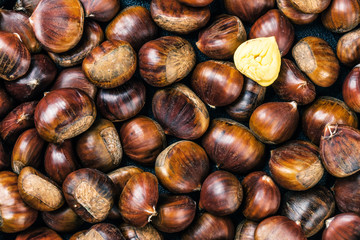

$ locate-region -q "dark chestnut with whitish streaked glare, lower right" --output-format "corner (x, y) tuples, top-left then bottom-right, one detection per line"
(281, 186), (335, 237)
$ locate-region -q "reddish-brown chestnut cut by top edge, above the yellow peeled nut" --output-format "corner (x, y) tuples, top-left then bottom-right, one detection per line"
(224, 0), (275, 23)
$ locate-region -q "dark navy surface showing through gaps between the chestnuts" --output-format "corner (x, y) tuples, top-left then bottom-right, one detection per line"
(0, 0), (351, 240)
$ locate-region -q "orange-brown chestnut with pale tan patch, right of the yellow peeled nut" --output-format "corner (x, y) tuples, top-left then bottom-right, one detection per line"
(292, 36), (340, 87)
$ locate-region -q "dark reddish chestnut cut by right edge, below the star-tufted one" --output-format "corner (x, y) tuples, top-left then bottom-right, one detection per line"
(332, 173), (360, 215)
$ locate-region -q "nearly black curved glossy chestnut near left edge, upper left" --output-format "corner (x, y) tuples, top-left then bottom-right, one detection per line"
(4, 54), (57, 102)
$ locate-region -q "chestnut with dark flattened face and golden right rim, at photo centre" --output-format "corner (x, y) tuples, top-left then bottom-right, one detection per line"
(152, 84), (210, 140)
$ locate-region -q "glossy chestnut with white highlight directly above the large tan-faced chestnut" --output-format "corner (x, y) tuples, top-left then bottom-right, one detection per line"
(105, 6), (158, 51)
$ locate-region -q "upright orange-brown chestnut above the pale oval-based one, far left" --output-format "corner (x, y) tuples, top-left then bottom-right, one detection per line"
(11, 128), (45, 174)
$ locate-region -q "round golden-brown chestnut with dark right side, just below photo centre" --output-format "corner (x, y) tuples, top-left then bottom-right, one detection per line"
(155, 141), (210, 193)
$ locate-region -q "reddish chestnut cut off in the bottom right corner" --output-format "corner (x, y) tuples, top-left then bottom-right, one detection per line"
(322, 213), (360, 240)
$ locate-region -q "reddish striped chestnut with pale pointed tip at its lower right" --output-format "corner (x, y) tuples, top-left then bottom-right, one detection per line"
(119, 172), (159, 227)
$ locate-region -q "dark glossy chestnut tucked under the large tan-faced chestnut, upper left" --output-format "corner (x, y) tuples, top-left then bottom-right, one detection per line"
(96, 79), (146, 122)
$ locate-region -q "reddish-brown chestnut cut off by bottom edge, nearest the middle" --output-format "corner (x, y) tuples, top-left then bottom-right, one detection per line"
(181, 213), (235, 240)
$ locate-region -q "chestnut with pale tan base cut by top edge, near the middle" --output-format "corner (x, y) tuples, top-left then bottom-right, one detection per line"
(150, 0), (210, 34)
